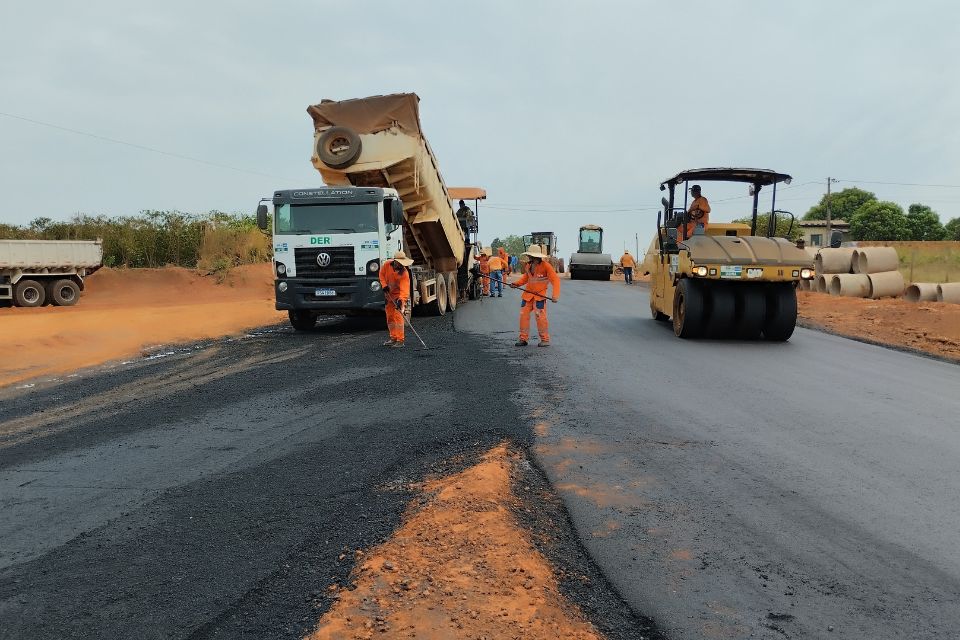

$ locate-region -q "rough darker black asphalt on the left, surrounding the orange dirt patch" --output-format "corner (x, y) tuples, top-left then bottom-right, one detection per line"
(0, 318), (658, 640)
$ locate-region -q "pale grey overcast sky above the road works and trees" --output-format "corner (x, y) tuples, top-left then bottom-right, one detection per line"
(0, 0), (960, 254)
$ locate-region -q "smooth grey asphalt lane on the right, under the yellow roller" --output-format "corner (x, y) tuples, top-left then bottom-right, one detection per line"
(457, 280), (960, 639)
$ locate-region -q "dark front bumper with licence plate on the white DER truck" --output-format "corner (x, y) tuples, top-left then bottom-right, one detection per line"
(273, 276), (384, 313)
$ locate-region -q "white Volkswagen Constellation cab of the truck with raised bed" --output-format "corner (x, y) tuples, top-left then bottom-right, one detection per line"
(257, 186), (404, 328)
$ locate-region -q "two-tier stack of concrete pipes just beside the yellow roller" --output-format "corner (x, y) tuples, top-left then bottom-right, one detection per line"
(814, 247), (904, 299)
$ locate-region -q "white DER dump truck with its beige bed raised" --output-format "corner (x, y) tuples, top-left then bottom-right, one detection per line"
(257, 93), (479, 330)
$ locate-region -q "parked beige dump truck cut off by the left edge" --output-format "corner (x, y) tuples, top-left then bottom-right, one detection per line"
(0, 240), (103, 307)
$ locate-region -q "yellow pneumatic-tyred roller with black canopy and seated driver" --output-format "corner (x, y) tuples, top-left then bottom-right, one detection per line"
(644, 168), (816, 341)
